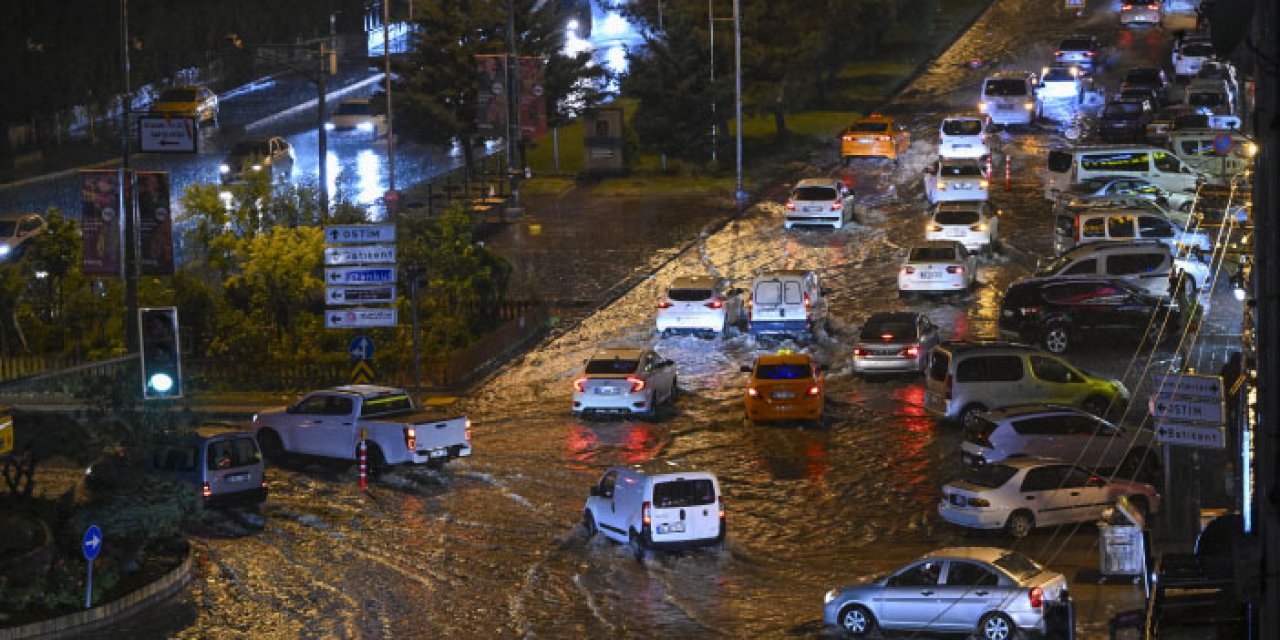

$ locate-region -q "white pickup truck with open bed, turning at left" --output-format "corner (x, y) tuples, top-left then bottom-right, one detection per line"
(253, 384), (471, 476)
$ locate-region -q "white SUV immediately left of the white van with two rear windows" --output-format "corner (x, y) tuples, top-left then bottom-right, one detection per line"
(657, 275), (742, 335)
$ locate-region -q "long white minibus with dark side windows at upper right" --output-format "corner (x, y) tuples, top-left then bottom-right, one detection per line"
(1044, 145), (1202, 201)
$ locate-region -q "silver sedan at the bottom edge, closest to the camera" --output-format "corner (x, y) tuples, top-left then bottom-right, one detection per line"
(823, 547), (1070, 640)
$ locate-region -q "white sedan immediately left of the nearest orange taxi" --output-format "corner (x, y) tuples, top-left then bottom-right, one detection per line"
(573, 349), (678, 417)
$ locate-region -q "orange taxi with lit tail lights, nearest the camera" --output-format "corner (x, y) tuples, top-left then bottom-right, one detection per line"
(742, 351), (827, 422)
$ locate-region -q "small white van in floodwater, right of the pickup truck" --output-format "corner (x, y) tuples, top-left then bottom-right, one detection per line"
(582, 463), (724, 558)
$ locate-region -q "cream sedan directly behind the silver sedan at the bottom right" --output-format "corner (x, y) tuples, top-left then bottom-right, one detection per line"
(938, 457), (1160, 538)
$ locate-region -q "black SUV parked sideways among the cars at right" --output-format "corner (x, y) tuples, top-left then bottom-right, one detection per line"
(1000, 276), (1183, 353)
